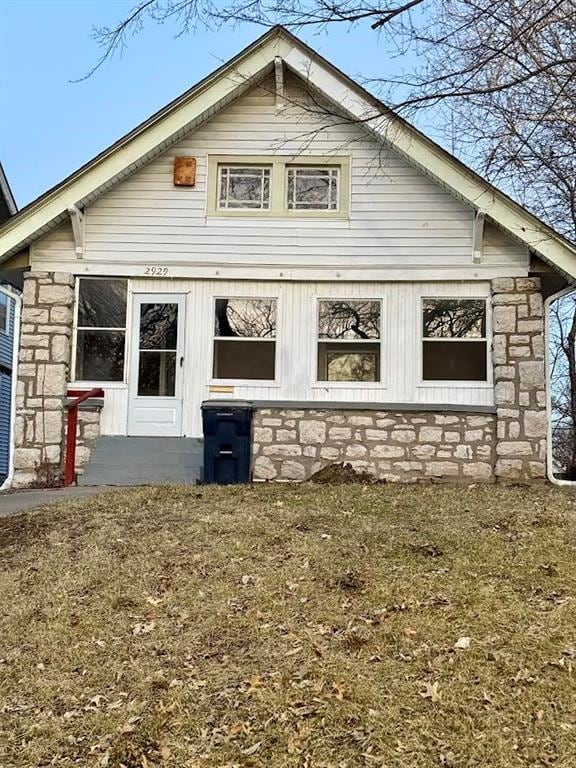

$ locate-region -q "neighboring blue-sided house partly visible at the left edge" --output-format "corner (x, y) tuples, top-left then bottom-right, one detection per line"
(0, 163), (18, 485)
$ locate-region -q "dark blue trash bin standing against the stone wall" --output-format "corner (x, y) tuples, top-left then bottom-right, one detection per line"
(202, 400), (254, 485)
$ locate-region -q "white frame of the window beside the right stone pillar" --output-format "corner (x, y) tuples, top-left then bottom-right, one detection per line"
(418, 294), (494, 389)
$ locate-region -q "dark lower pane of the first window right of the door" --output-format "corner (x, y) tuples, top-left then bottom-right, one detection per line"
(213, 340), (276, 381)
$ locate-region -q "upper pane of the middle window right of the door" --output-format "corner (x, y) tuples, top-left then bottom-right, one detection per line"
(318, 300), (380, 339)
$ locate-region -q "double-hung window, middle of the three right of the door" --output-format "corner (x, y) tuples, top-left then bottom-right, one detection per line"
(317, 299), (381, 382)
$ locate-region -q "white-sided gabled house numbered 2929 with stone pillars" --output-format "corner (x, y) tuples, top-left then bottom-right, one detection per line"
(0, 28), (576, 486)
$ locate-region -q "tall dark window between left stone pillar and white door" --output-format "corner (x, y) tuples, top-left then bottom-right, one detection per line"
(76, 278), (128, 381)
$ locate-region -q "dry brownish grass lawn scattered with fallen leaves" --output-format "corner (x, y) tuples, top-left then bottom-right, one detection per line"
(0, 486), (576, 768)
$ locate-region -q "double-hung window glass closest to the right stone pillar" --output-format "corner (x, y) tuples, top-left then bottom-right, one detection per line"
(422, 298), (488, 382)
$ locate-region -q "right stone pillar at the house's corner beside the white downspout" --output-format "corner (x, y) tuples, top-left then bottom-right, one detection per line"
(492, 277), (548, 482)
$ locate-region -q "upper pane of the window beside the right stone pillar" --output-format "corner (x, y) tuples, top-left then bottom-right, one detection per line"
(423, 299), (486, 339)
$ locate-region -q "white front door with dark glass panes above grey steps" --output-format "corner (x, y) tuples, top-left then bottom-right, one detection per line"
(128, 293), (185, 437)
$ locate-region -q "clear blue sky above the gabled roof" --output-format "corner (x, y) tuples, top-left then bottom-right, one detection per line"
(0, 0), (424, 207)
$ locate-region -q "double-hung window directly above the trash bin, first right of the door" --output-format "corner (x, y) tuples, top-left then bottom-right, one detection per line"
(212, 298), (276, 381)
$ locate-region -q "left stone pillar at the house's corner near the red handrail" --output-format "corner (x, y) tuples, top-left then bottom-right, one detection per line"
(13, 272), (74, 488)
